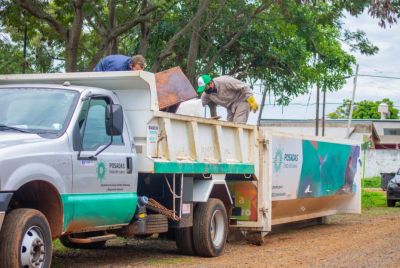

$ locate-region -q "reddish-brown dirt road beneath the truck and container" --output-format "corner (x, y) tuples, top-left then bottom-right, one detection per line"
(53, 207), (400, 267)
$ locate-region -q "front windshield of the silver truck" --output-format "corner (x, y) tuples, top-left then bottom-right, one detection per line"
(0, 88), (79, 134)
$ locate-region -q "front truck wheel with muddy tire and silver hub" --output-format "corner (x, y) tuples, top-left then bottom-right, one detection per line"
(0, 208), (53, 267)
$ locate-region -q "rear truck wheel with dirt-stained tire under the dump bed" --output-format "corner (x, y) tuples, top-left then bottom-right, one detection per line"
(193, 198), (228, 257)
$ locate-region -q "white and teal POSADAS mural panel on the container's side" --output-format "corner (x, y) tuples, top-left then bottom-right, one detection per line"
(271, 136), (361, 201)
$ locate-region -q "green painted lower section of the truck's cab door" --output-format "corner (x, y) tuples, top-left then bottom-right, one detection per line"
(61, 192), (137, 231)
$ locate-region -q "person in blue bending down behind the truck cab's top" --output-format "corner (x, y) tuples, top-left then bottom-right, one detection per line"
(93, 55), (146, 72)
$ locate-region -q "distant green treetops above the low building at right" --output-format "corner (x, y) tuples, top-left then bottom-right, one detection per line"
(328, 98), (399, 119)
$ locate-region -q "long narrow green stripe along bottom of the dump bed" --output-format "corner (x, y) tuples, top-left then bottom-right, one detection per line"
(154, 161), (254, 174)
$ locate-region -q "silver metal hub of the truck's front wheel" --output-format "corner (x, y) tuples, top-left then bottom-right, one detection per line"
(21, 226), (46, 268)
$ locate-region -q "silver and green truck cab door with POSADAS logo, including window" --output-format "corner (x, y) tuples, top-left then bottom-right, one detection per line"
(64, 95), (137, 231)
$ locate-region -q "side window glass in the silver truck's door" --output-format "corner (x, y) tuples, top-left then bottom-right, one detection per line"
(79, 99), (123, 151)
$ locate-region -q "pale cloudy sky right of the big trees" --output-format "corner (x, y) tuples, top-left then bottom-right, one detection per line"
(249, 10), (400, 124)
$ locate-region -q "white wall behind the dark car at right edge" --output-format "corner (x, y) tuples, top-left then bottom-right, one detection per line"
(365, 149), (400, 178)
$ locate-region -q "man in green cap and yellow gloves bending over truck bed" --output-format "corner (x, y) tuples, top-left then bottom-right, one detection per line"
(197, 74), (258, 124)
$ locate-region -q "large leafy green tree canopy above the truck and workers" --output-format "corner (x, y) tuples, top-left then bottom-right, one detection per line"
(0, 0), (399, 104)
